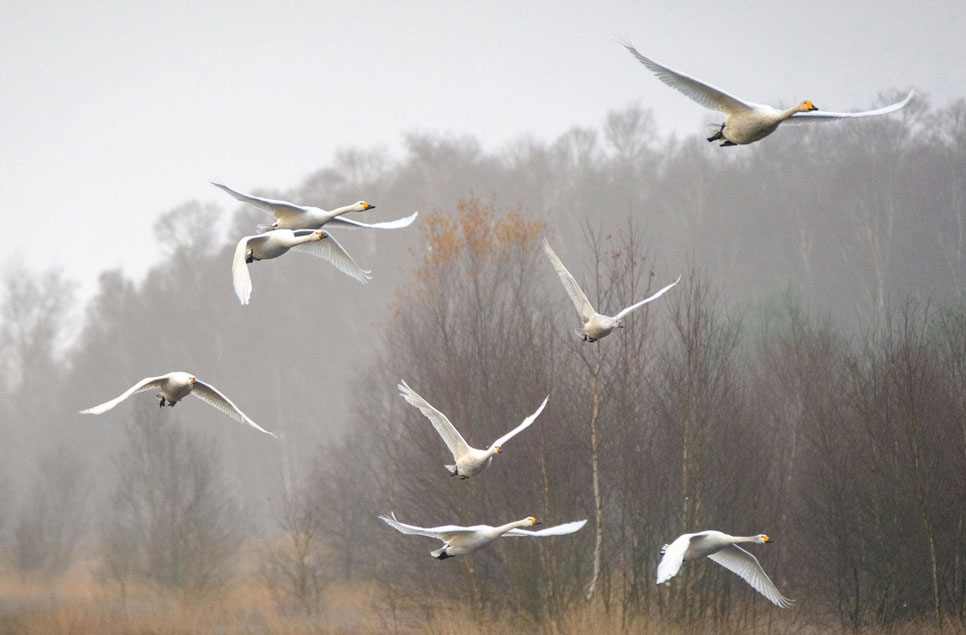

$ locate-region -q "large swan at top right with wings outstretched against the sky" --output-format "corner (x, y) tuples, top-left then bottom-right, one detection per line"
(620, 41), (913, 146)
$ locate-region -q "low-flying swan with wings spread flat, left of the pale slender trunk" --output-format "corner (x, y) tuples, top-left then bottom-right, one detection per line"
(379, 514), (587, 560)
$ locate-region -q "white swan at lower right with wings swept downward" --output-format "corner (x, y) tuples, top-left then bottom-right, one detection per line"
(657, 530), (794, 608)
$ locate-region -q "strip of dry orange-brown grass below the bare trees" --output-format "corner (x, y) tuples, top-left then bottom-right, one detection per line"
(0, 569), (964, 635)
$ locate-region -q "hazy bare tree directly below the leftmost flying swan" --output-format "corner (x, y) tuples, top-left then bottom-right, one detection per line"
(101, 401), (244, 597)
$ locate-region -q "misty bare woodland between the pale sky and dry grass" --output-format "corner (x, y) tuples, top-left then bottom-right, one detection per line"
(0, 95), (966, 633)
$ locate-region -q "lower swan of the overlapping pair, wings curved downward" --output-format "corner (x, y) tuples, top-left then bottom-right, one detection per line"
(231, 229), (372, 304)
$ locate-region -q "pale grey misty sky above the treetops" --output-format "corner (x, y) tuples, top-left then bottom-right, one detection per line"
(0, 0), (966, 292)
